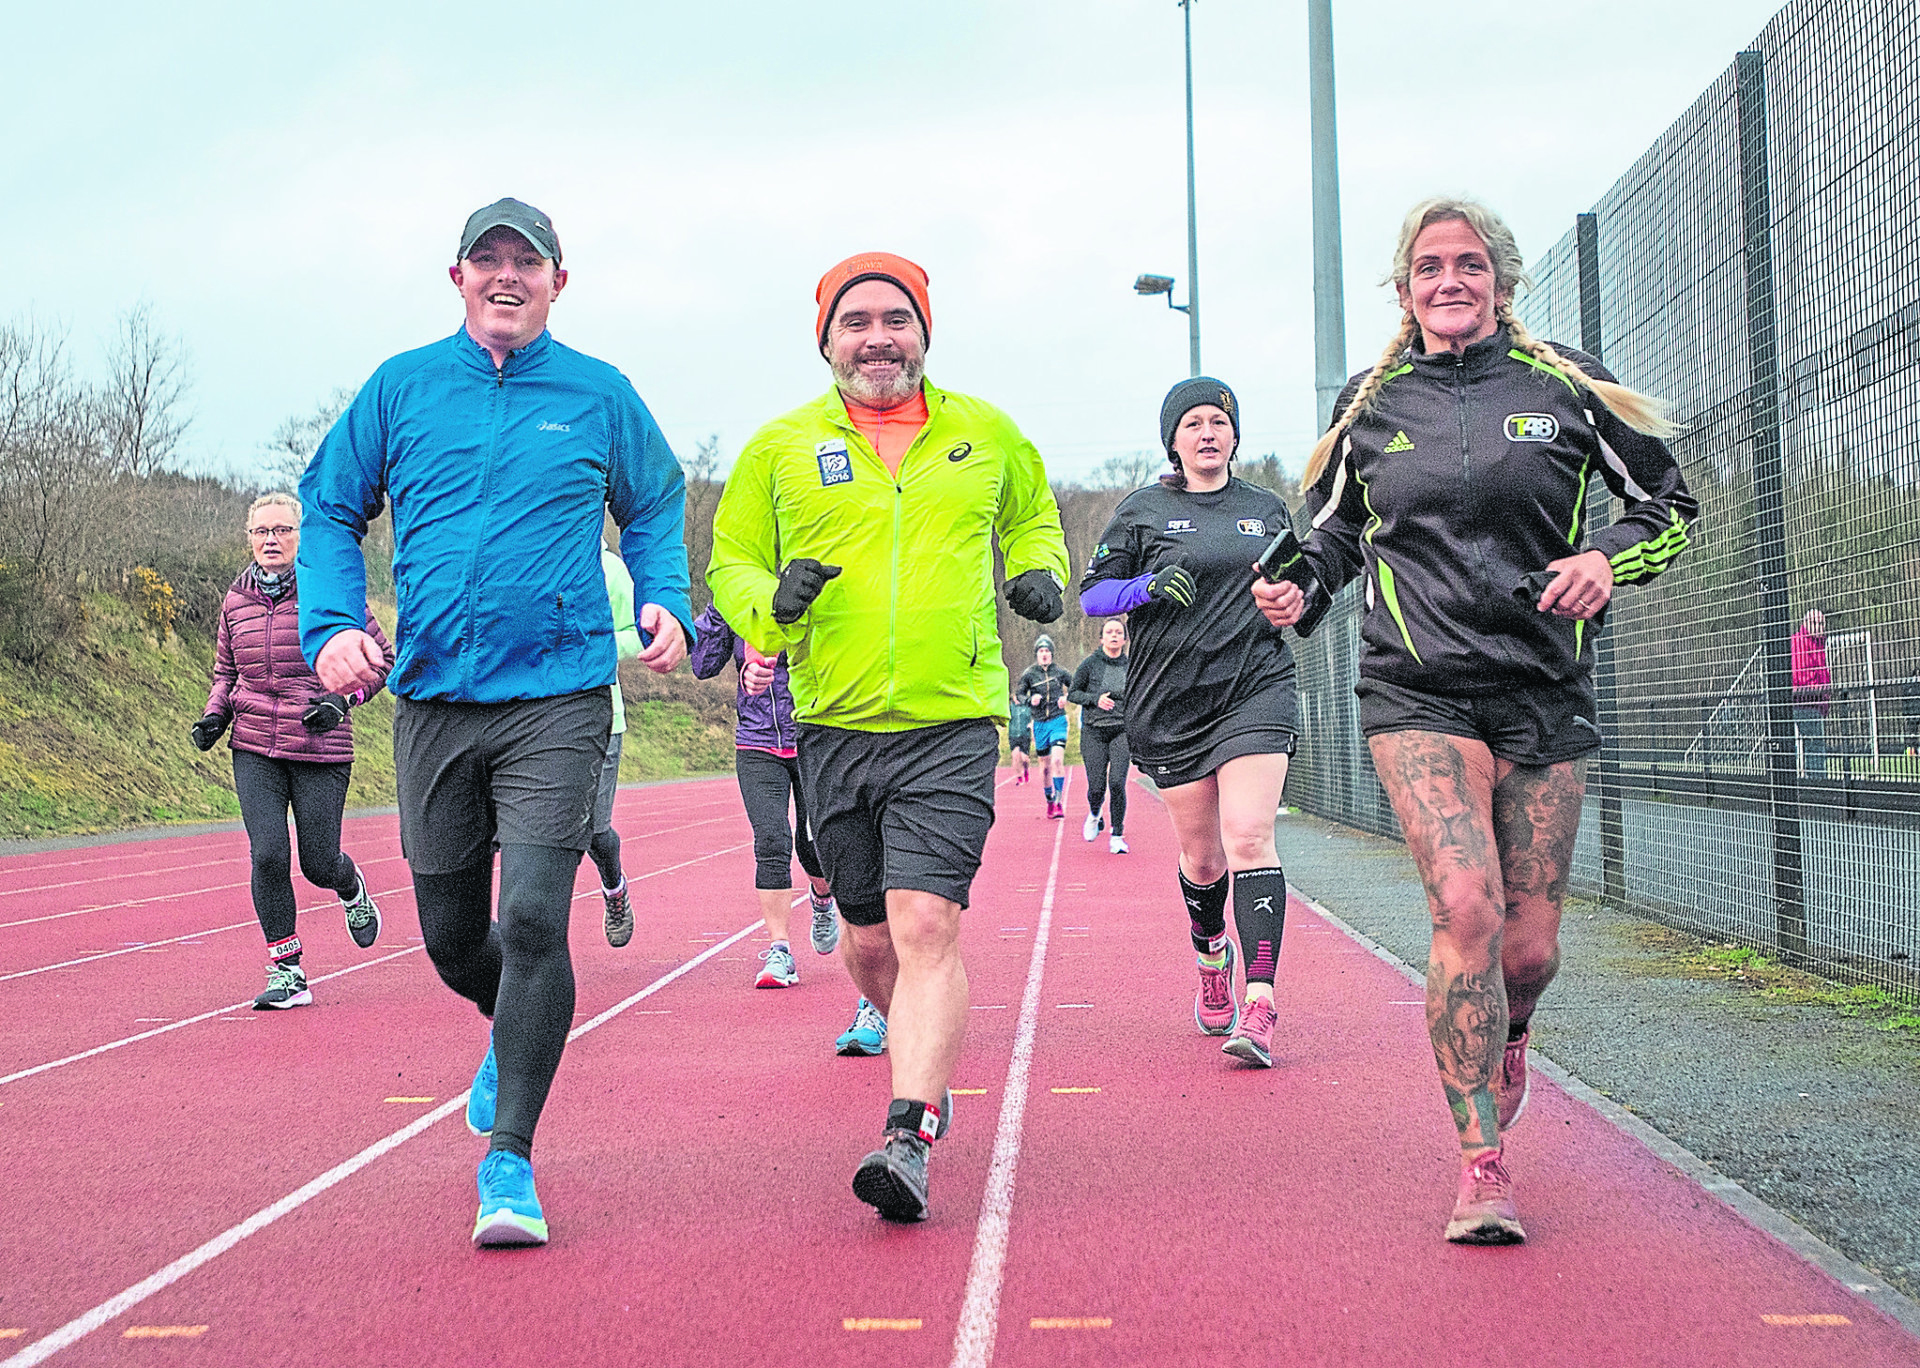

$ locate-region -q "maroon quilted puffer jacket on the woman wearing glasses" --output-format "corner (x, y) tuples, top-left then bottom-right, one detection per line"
(207, 565), (394, 763)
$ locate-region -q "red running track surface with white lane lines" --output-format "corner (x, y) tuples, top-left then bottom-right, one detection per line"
(0, 780), (1920, 1368)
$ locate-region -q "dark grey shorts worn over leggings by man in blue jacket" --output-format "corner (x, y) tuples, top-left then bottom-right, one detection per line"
(394, 688), (612, 874)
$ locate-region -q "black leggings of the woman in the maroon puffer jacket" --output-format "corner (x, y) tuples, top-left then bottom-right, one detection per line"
(232, 751), (359, 945)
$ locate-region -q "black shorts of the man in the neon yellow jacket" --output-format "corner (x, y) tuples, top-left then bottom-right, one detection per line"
(801, 717), (1000, 926)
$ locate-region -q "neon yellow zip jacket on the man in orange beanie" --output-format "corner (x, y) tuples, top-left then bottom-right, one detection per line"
(707, 384), (1069, 732)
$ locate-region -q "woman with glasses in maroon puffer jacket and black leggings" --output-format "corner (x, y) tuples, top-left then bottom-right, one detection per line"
(192, 494), (394, 1009)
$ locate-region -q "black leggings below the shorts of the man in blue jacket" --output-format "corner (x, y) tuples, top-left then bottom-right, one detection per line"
(413, 843), (580, 1159)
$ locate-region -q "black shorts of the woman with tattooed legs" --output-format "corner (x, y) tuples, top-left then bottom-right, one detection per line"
(1354, 678), (1599, 765)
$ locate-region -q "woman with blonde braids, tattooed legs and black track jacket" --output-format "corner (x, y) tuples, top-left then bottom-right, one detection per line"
(1256, 200), (1697, 1245)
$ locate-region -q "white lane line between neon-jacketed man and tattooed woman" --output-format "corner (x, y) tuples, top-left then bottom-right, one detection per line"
(952, 774), (1073, 1368)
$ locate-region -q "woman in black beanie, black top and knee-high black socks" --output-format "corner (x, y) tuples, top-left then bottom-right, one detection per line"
(1081, 377), (1300, 1068)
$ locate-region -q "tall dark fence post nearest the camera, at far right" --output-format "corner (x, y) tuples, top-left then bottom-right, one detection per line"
(1734, 50), (1807, 959)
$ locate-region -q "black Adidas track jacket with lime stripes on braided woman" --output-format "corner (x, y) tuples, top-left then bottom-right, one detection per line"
(1306, 329), (1699, 696)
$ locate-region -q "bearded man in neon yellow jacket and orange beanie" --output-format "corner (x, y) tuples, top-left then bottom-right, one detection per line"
(707, 252), (1069, 1220)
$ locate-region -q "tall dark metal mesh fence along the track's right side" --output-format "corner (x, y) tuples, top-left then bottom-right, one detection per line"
(1288, 0), (1920, 997)
